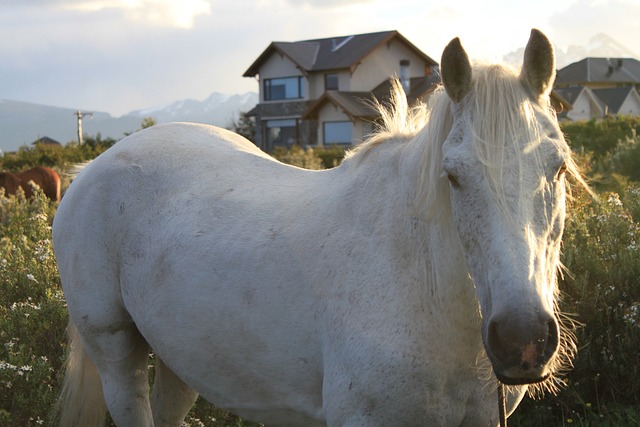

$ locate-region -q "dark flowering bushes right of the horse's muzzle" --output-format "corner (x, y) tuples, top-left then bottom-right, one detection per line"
(512, 187), (640, 426)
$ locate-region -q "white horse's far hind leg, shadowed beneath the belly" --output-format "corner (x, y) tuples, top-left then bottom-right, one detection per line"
(151, 358), (198, 427)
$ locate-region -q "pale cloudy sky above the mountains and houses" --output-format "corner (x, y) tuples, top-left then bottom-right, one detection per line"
(0, 0), (640, 116)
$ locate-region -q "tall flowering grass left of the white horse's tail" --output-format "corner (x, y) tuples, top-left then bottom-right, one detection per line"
(0, 190), (67, 426)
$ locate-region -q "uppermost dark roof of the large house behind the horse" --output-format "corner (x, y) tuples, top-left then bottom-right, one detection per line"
(243, 31), (438, 77)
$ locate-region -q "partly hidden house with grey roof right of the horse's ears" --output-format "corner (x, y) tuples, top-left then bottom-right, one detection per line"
(555, 58), (640, 120)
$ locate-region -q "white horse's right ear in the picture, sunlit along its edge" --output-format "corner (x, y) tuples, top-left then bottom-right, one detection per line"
(520, 28), (556, 98)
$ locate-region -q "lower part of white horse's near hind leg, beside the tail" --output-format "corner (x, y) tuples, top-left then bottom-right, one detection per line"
(85, 323), (153, 427)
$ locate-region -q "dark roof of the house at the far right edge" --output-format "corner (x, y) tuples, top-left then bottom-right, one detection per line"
(555, 58), (640, 86)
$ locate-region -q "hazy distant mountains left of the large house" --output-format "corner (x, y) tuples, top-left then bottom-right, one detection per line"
(0, 92), (258, 152)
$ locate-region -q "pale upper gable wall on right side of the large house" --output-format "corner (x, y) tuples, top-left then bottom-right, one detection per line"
(350, 40), (425, 92)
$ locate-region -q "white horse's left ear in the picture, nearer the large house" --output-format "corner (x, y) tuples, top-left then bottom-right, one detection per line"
(440, 37), (471, 102)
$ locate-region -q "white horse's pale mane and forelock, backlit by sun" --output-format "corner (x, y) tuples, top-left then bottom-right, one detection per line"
(346, 64), (587, 224)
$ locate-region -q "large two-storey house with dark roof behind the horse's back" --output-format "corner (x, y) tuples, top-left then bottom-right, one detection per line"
(244, 31), (440, 151)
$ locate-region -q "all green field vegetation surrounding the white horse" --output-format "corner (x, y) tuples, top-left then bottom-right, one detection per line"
(0, 118), (640, 427)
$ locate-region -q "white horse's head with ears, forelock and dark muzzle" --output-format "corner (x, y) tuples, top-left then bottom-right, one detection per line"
(441, 30), (574, 384)
